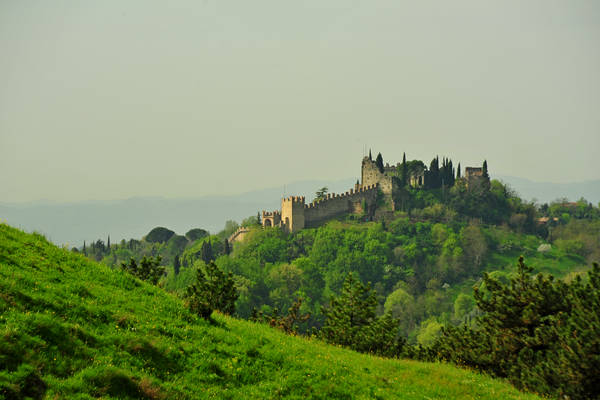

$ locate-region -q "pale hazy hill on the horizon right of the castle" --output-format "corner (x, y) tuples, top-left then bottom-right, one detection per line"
(492, 175), (600, 205)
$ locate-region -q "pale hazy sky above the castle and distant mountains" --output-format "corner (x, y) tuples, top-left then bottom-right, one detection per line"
(0, 0), (600, 202)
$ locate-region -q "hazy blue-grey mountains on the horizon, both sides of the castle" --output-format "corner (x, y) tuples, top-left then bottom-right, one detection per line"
(0, 176), (600, 246)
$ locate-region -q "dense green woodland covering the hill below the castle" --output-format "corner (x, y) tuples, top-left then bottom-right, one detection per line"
(73, 158), (600, 398)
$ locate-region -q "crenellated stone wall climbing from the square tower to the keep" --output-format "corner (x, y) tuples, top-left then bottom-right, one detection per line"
(304, 185), (377, 228)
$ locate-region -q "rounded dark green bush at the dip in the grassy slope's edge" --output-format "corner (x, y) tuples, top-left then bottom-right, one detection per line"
(187, 262), (239, 319)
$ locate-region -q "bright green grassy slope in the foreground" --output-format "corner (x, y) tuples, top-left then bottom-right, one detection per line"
(0, 224), (537, 399)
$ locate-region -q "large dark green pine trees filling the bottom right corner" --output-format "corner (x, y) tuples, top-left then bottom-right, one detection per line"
(432, 257), (600, 399)
